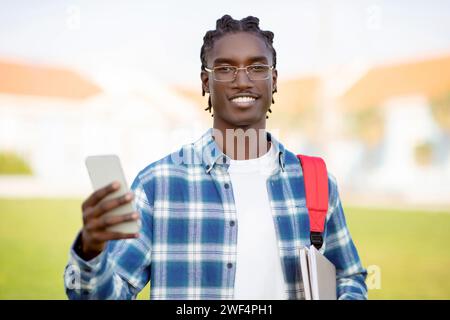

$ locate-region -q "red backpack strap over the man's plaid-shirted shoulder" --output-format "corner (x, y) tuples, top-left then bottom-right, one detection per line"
(297, 154), (328, 249)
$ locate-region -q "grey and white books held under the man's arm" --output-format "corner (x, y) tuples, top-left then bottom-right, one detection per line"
(300, 246), (337, 300)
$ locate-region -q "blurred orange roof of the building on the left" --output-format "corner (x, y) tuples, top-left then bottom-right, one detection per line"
(0, 61), (102, 99)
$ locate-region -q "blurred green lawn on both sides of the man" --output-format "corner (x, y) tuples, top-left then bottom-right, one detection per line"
(0, 199), (450, 299)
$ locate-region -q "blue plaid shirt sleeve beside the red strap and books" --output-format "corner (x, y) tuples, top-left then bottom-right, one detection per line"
(321, 175), (367, 300)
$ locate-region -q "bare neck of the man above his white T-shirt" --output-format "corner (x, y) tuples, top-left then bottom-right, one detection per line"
(213, 121), (270, 160)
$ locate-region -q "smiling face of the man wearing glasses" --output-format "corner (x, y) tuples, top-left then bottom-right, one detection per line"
(201, 32), (277, 129)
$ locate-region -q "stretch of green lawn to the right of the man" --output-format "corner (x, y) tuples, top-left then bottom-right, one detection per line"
(346, 208), (450, 299)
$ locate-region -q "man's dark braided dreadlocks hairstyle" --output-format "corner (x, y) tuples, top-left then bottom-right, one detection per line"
(200, 14), (277, 119)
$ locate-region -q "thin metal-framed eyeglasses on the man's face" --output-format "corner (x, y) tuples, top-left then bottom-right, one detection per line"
(205, 64), (273, 82)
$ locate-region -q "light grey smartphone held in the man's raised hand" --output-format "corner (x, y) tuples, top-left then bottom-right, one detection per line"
(85, 155), (141, 233)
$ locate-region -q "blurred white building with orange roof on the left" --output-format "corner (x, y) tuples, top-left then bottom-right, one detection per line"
(0, 58), (204, 196)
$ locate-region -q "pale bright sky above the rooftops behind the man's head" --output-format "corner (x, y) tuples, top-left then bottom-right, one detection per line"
(0, 0), (450, 85)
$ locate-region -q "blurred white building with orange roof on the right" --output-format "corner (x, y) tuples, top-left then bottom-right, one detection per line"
(339, 56), (450, 204)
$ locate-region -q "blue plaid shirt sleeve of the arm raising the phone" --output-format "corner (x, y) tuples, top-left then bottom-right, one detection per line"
(64, 176), (153, 300)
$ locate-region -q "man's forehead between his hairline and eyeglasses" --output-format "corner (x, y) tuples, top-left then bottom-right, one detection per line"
(208, 32), (272, 65)
